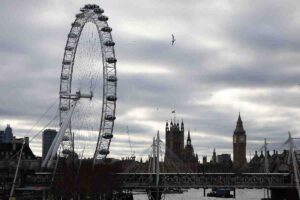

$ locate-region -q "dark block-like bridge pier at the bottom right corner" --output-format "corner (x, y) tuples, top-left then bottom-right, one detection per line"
(271, 188), (299, 200)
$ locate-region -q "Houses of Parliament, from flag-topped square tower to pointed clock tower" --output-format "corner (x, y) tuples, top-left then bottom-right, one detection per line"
(165, 114), (247, 168)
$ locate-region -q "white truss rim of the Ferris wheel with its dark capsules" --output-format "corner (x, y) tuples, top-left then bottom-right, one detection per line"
(59, 4), (117, 163)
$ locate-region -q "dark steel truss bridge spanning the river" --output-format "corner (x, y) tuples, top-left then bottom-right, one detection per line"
(9, 172), (298, 200)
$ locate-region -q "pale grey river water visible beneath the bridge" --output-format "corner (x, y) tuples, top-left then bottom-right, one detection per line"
(134, 189), (264, 200)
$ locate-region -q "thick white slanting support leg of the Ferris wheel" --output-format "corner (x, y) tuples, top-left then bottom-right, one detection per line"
(42, 101), (77, 167)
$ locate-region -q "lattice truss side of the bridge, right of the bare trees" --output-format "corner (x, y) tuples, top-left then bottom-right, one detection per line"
(115, 173), (295, 189)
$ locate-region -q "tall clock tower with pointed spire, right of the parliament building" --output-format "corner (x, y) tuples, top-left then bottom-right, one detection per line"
(233, 114), (247, 168)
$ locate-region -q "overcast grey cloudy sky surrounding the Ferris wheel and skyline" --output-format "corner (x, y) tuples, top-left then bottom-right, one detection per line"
(0, 0), (300, 158)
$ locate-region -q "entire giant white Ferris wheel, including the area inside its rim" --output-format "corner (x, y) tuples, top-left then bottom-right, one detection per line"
(47, 4), (117, 166)
